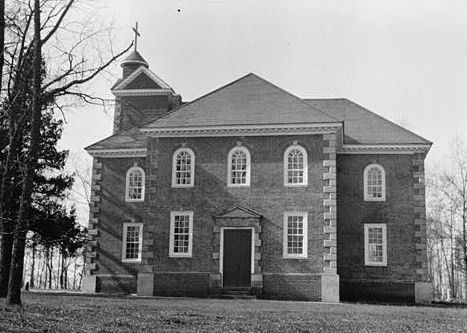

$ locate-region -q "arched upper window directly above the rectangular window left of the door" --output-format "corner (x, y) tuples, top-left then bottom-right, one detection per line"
(172, 148), (195, 187)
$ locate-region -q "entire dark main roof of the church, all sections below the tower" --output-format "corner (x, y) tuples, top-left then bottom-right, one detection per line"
(86, 74), (431, 150)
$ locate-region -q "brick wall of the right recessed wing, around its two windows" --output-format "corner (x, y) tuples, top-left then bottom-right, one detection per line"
(337, 154), (417, 299)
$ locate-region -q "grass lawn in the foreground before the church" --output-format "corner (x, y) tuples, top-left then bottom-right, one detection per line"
(0, 293), (467, 332)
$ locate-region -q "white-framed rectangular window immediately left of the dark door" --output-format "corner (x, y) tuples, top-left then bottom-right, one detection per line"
(169, 211), (193, 257)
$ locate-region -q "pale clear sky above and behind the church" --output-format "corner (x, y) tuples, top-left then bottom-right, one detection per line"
(61, 0), (467, 220)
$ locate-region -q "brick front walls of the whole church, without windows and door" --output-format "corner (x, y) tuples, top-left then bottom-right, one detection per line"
(87, 135), (426, 301)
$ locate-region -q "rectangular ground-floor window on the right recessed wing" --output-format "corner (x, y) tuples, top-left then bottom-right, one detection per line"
(365, 224), (387, 266)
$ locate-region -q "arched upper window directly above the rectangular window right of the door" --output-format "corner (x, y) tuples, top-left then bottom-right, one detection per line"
(284, 145), (308, 186)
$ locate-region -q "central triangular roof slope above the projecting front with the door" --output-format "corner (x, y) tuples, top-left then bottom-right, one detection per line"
(143, 74), (339, 129)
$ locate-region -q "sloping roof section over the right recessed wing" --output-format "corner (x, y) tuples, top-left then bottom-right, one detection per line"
(304, 98), (431, 144)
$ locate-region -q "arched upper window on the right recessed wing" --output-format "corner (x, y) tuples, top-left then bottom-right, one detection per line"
(363, 164), (386, 201)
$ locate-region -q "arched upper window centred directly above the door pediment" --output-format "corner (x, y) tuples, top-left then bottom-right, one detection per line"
(227, 147), (250, 186)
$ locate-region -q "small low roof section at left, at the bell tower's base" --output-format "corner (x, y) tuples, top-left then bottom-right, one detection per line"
(84, 127), (147, 150)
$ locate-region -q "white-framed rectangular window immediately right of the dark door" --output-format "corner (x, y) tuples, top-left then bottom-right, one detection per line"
(283, 212), (308, 258)
